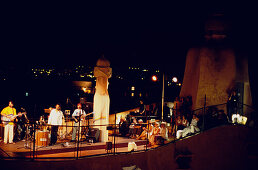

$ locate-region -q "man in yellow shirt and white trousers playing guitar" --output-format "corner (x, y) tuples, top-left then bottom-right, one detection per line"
(1, 101), (16, 144)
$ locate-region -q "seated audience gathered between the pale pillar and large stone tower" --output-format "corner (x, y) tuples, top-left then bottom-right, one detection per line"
(119, 96), (200, 146)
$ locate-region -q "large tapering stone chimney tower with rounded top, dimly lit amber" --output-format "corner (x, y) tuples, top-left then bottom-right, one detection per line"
(180, 14), (252, 109)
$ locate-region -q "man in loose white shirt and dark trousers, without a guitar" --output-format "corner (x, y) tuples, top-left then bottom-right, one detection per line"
(48, 104), (64, 145)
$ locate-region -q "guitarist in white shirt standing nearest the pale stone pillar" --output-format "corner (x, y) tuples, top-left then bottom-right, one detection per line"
(71, 103), (86, 142)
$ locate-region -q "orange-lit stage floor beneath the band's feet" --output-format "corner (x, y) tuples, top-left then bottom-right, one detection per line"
(0, 136), (149, 158)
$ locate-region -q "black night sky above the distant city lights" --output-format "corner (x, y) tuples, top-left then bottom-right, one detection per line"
(1, 1), (256, 68)
